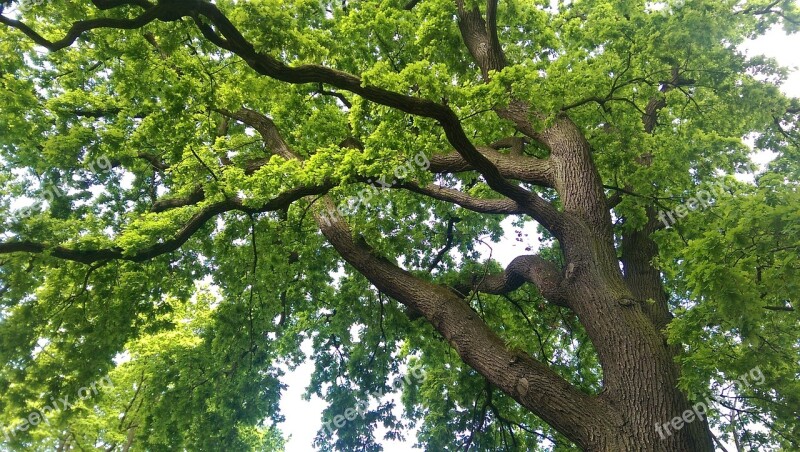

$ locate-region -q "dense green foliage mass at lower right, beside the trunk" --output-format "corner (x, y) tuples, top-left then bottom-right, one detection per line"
(665, 172), (800, 448)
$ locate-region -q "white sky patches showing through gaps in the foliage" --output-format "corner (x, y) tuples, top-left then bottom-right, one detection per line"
(279, 24), (800, 452)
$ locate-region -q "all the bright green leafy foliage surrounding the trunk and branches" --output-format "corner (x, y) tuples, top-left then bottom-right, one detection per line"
(0, 0), (800, 451)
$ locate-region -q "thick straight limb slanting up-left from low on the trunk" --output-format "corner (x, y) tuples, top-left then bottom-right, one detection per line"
(315, 199), (616, 444)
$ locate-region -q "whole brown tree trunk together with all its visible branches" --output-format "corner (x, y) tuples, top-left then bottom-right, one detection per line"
(0, 0), (713, 452)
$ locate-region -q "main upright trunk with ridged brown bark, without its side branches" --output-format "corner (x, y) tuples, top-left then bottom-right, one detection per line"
(458, 0), (714, 451)
